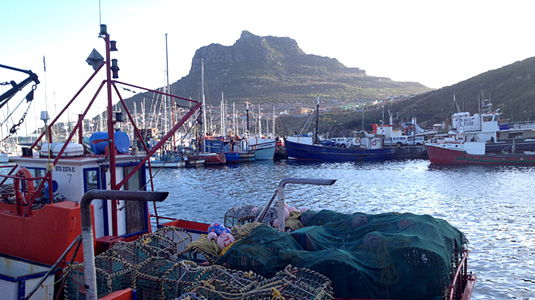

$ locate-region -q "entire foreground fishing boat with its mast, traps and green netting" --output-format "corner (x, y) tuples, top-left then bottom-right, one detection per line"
(0, 25), (476, 300)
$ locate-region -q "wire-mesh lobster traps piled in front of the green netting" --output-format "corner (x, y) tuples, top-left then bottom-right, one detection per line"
(64, 226), (333, 300)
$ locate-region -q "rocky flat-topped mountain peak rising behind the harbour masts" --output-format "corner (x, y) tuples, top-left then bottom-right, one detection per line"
(174, 30), (429, 103)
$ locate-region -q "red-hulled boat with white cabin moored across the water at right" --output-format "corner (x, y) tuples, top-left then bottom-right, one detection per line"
(425, 132), (535, 165)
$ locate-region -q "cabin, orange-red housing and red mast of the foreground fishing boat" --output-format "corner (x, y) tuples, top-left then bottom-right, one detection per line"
(0, 25), (202, 299)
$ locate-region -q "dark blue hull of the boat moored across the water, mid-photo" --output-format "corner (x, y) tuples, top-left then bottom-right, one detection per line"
(285, 140), (396, 161)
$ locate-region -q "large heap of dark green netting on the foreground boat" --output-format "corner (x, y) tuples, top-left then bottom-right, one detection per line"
(216, 210), (467, 300)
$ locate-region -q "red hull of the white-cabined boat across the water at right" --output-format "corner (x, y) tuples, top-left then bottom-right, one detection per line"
(426, 145), (535, 165)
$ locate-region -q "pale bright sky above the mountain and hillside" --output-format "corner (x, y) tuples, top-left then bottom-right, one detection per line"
(0, 0), (535, 131)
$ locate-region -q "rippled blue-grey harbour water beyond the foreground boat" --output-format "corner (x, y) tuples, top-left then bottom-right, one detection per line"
(153, 160), (535, 299)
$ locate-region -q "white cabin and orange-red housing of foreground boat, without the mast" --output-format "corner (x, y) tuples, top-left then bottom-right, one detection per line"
(0, 142), (151, 264)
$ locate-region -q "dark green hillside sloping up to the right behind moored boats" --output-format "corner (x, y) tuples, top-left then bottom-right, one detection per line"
(282, 57), (535, 136)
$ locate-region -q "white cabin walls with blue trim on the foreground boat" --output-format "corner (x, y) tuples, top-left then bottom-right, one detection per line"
(13, 153), (149, 239)
